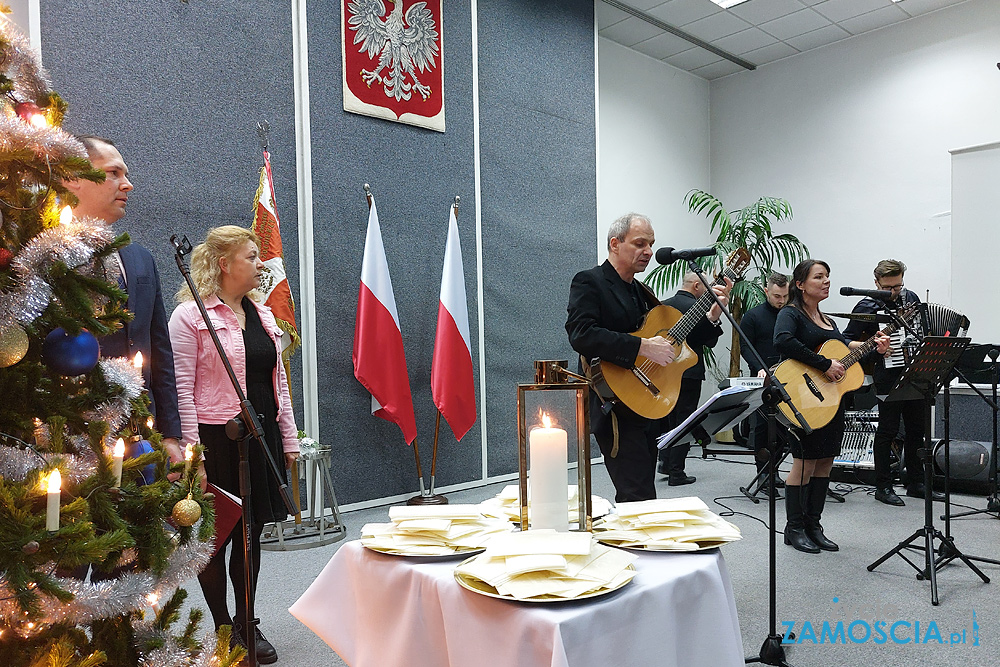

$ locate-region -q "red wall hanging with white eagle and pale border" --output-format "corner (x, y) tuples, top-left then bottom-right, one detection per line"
(341, 0), (444, 132)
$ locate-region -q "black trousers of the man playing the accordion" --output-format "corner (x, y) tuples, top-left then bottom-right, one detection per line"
(872, 400), (927, 489)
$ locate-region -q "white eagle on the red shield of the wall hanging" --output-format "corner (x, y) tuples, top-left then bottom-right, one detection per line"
(347, 0), (438, 102)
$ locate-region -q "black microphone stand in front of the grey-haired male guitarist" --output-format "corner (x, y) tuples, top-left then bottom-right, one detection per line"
(688, 260), (812, 667)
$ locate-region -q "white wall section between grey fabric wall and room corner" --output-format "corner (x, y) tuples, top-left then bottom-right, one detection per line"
(597, 38), (710, 261)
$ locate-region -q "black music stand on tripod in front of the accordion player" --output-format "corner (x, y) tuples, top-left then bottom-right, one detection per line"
(868, 336), (990, 606)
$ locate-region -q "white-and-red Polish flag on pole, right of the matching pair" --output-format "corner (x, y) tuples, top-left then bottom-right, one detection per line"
(431, 206), (476, 440)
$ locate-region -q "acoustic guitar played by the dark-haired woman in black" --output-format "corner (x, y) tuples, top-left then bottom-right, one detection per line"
(773, 304), (919, 429)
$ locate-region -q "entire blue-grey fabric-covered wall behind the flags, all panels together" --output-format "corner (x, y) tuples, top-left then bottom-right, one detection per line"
(42, 0), (596, 503)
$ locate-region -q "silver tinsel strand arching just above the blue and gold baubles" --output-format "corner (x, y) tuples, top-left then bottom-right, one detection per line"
(0, 218), (117, 330)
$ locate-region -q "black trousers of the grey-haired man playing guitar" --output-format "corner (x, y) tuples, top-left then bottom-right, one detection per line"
(594, 416), (660, 503)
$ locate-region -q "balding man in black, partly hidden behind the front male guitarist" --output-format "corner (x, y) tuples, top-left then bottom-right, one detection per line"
(657, 271), (728, 486)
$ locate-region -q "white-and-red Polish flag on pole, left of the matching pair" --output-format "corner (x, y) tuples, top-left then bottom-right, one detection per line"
(353, 199), (417, 444)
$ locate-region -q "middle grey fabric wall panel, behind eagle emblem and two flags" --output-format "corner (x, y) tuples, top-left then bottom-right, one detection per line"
(309, 2), (482, 503)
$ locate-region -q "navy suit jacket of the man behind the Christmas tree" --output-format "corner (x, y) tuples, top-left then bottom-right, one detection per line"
(101, 243), (181, 439)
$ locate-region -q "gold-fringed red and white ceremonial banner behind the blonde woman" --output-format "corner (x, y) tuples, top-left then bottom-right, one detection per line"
(250, 151), (302, 366)
